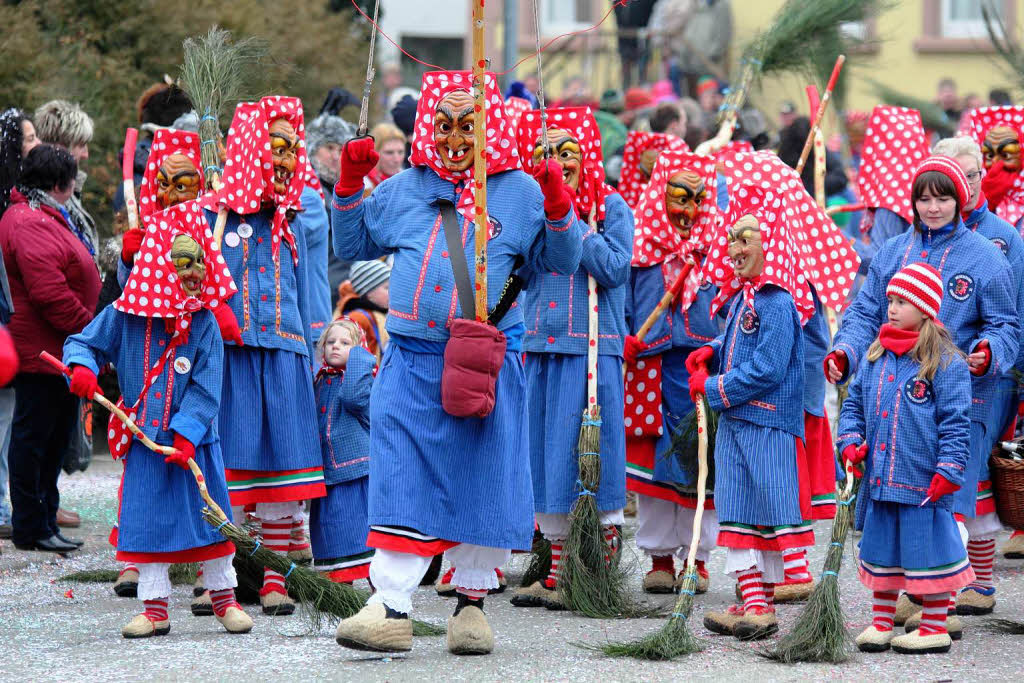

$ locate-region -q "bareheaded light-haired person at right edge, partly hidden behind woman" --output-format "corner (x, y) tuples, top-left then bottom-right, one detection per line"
(935, 136), (1024, 602)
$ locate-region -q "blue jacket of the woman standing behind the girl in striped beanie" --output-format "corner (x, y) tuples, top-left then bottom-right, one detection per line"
(833, 219), (1021, 422)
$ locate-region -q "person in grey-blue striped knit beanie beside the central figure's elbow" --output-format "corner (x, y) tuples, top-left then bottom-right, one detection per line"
(334, 261), (391, 362)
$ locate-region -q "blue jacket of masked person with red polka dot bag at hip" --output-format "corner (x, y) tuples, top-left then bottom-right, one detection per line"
(626, 265), (722, 357)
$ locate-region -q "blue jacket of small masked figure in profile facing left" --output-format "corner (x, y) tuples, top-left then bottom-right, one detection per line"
(705, 285), (804, 438)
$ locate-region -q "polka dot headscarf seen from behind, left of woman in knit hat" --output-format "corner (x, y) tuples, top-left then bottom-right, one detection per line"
(857, 105), (928, 223)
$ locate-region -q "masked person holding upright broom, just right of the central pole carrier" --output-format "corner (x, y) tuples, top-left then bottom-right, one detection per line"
(512, 102), (633, 609)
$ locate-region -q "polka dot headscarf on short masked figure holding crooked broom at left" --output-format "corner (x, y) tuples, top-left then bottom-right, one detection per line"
(114, 201), (238, 317)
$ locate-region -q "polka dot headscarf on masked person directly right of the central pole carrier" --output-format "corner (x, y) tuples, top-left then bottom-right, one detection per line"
(517, 106), (615, 220)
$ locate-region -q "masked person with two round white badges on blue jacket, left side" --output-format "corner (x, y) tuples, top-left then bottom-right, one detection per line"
(200, 96), (326, 615)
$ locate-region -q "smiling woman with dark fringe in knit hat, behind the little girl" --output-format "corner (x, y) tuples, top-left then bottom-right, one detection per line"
(824, 155), (1021, 624)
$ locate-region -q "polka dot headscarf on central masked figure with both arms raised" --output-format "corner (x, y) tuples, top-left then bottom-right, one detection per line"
(409, 71), (519, 220)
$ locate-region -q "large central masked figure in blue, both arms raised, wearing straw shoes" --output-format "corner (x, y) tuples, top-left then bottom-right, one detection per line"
(331, 72), (583, 653)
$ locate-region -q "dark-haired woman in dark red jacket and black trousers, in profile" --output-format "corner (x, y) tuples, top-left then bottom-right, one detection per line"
(0, 144), (100, 552)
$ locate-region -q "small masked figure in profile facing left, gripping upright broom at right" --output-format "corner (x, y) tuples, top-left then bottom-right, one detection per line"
(687, 184), (814, 640)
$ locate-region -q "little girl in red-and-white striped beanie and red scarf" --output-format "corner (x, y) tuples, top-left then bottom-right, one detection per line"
(838, 263), (974, 654)
